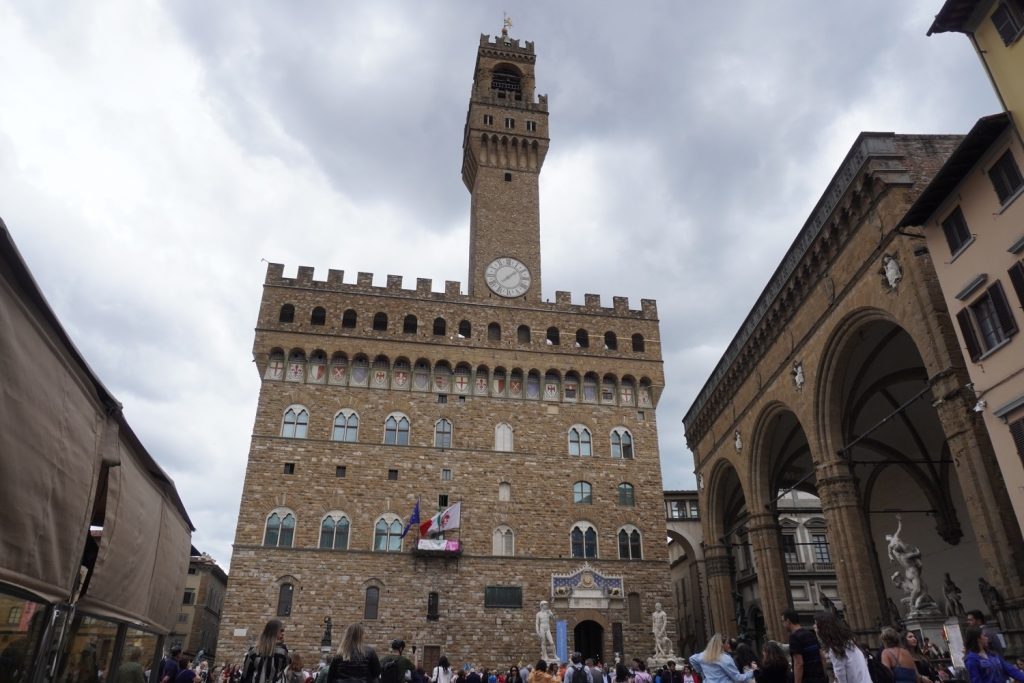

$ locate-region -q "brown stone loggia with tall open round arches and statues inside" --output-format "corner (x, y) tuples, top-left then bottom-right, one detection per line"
(684, 133), (1024, 642)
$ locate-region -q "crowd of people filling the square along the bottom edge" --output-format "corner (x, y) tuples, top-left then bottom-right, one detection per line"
(172, 610), (1024, 683)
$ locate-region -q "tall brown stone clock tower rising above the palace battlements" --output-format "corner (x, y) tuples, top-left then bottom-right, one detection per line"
(462, 24), (549, 302)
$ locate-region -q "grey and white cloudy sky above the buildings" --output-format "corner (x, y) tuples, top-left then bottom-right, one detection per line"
(0, 0), (998, 565)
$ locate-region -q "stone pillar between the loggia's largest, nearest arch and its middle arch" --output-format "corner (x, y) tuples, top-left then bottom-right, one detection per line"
(815, 460), (887, 635)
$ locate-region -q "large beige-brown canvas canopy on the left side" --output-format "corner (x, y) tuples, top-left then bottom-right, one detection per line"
(0, 221), (193, 631)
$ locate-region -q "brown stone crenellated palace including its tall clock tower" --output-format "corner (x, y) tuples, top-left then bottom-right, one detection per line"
(218, 30), (674, 667)
